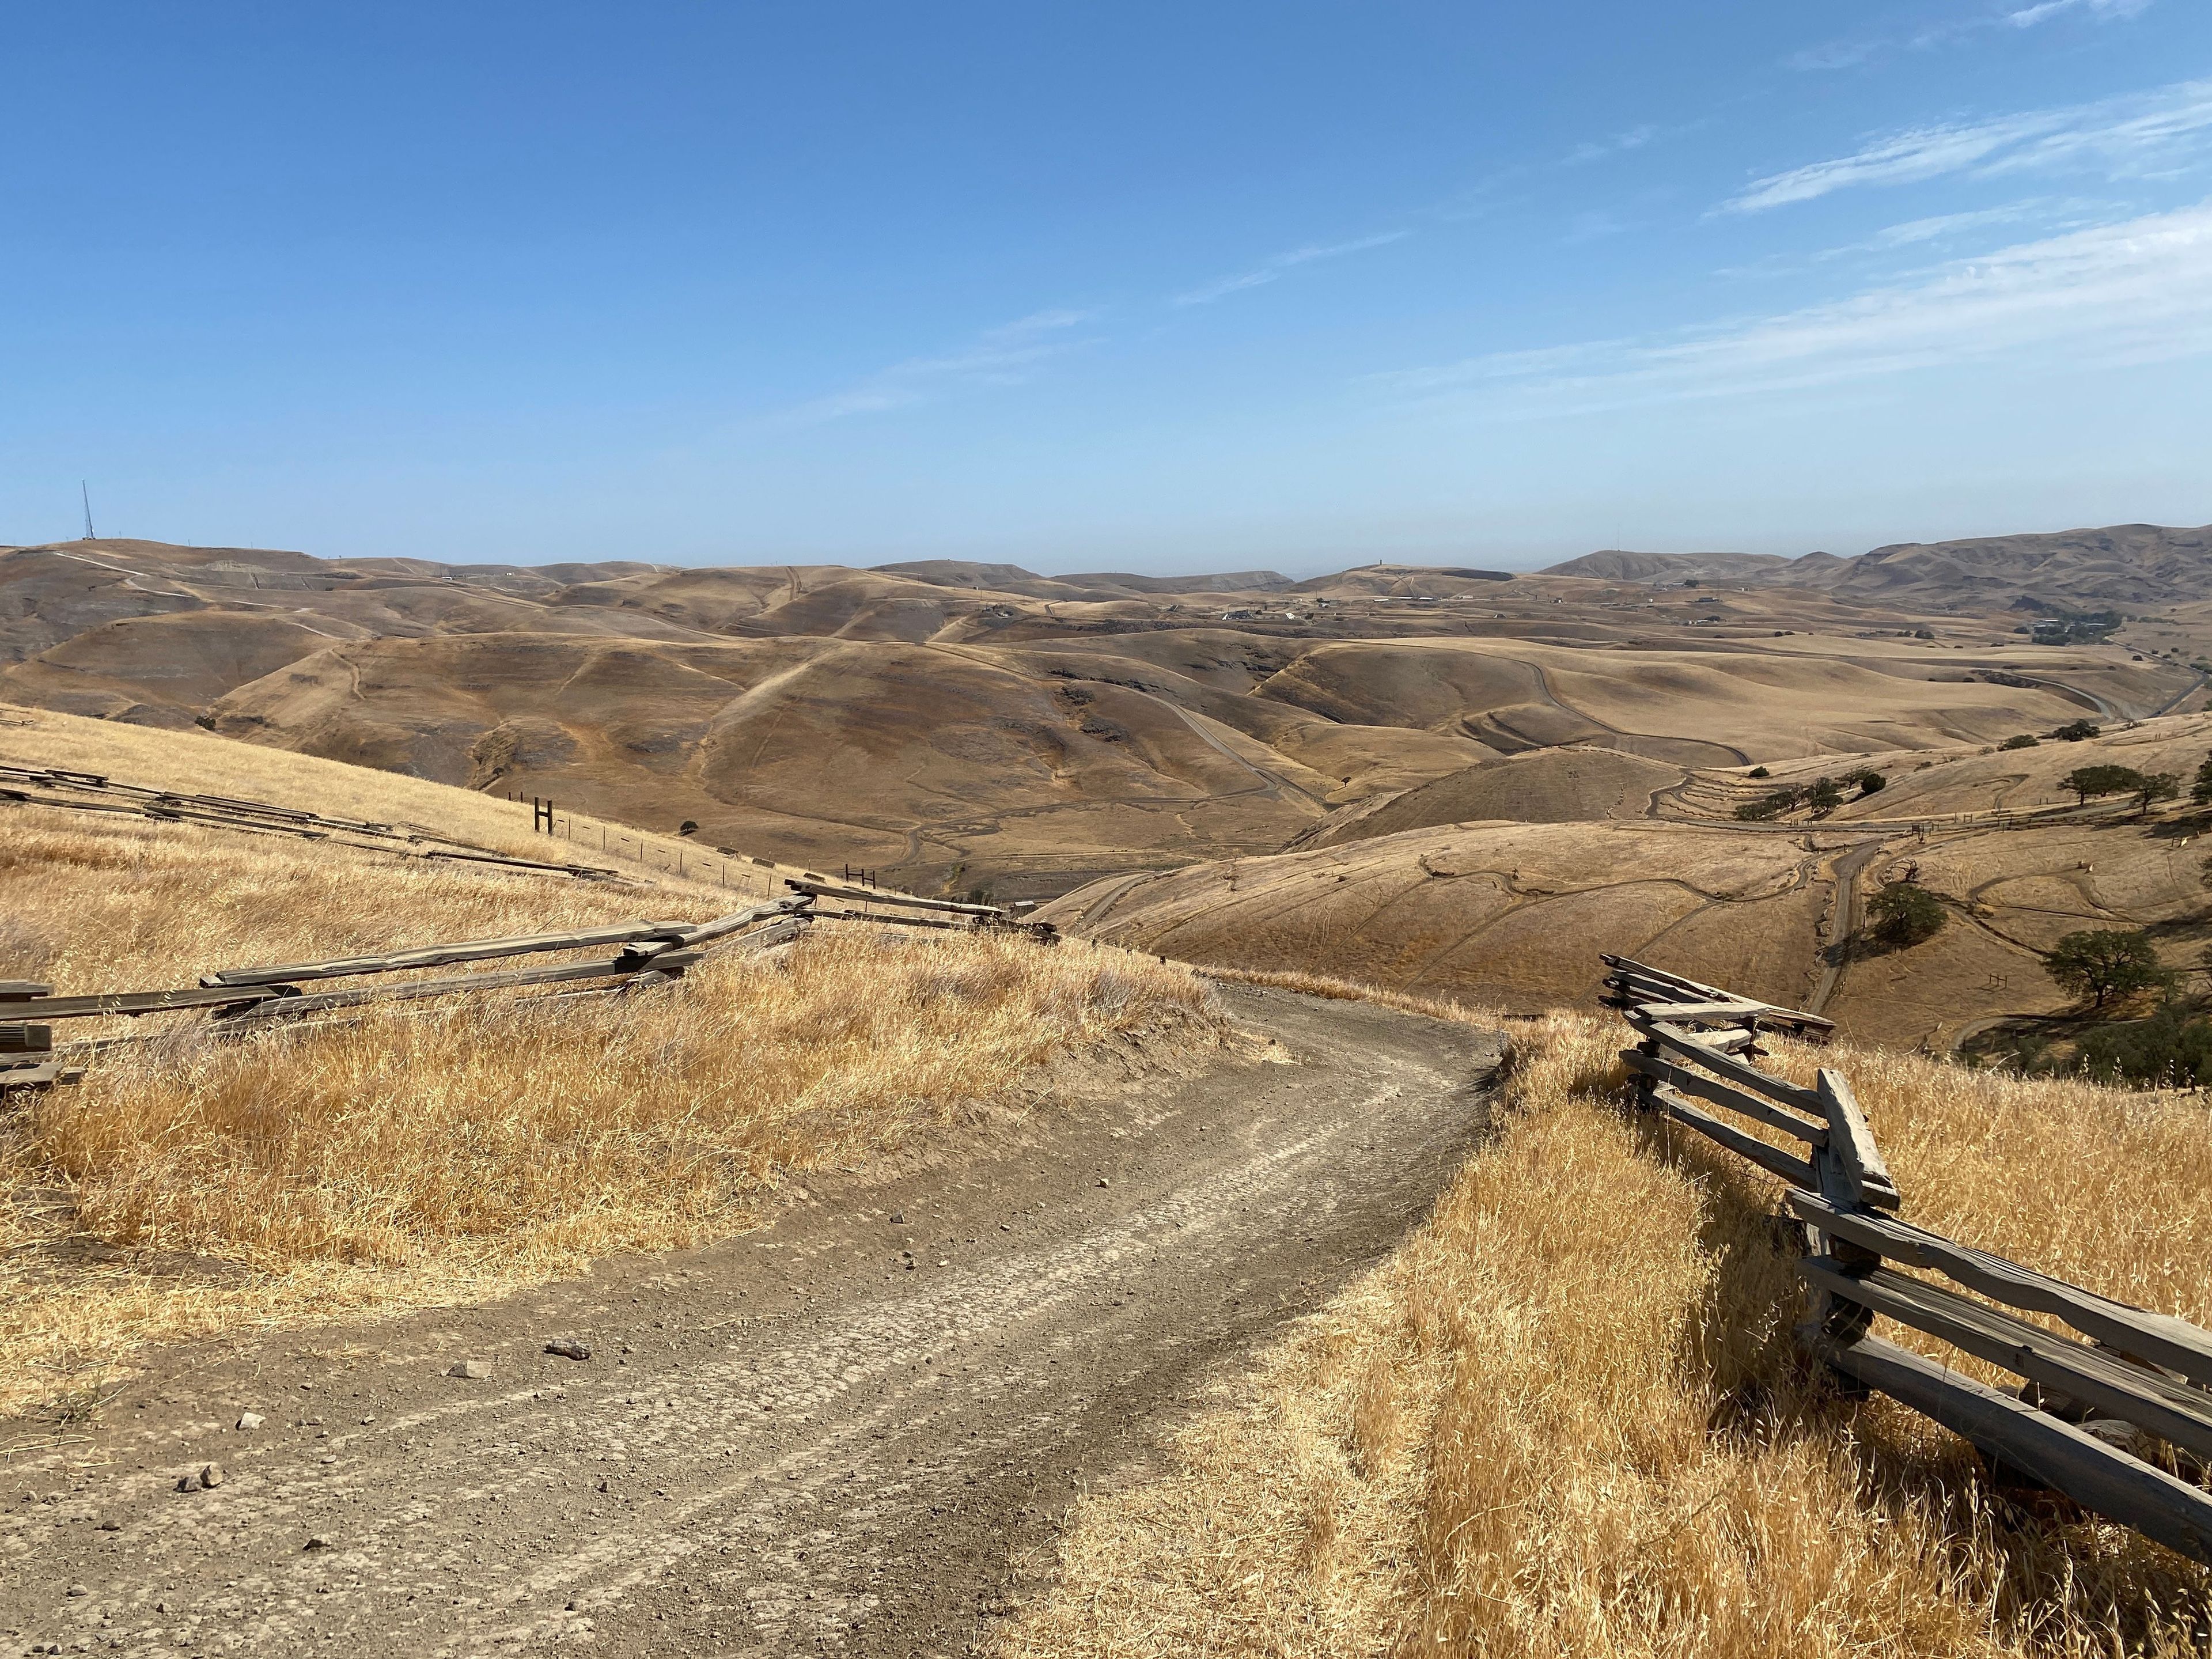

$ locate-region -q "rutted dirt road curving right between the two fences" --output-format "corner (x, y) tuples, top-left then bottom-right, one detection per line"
(0, 987), (1500, 1657)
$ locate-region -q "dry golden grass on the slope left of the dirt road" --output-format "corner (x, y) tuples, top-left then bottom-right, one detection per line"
(0, 778), (1214, 1411)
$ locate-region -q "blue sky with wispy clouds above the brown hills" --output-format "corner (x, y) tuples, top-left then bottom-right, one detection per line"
(0, 0), (2212, 571)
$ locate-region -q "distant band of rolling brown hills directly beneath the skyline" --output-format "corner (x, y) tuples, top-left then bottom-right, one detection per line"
(0, 531), (2203, 898)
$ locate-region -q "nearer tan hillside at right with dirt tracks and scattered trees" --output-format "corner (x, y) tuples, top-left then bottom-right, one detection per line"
(1040, 714), (2212, 1051)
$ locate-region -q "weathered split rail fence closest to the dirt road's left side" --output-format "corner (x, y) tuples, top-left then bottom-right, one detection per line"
(0, 880), (1058, 1093)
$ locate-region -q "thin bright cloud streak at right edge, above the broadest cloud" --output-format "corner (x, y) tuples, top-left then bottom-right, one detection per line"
(1714, 79), (2212, 213)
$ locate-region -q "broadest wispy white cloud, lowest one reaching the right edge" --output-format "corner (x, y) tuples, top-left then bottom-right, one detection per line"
(1372, 201), (2212, 414)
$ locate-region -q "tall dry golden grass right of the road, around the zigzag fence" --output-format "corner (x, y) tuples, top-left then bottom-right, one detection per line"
(1004, 1009), (2212, 1659)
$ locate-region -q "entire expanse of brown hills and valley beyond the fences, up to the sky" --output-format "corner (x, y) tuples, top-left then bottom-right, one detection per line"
(0, 527), (2212, 1048)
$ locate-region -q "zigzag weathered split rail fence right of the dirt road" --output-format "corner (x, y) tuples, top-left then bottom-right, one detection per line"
(1604, 956), (2212, 1564)
